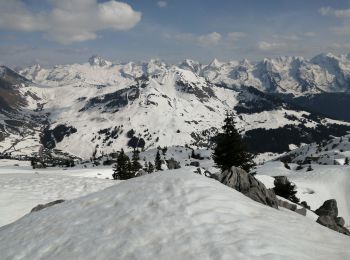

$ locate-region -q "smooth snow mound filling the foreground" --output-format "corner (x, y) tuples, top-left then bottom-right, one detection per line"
(0, 171), (350, 259)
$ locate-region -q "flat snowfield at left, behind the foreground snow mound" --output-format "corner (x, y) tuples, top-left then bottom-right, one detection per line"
(0, 160), (117, 226)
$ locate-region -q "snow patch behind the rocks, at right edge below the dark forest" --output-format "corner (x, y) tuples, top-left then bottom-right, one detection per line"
(257, 162), (350, 226)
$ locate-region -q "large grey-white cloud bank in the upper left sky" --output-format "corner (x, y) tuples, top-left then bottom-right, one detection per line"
(0, 0), (141, 44)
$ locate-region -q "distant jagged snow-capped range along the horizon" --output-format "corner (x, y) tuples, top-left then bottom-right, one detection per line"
(20, 53), (350, 95)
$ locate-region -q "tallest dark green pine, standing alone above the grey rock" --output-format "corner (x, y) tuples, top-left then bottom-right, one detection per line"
(213, 113), (255, 172)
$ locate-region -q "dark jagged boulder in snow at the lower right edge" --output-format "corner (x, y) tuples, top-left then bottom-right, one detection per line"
(315, 199), (350, 236)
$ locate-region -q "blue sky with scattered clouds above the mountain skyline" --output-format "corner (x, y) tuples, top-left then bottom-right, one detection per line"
(0, 0), (350, 67)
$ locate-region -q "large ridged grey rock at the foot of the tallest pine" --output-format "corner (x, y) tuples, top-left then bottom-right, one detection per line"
(220, 167), (278, 209)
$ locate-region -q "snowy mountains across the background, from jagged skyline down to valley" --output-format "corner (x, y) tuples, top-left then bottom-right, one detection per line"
(0, 54), (350, 158)
